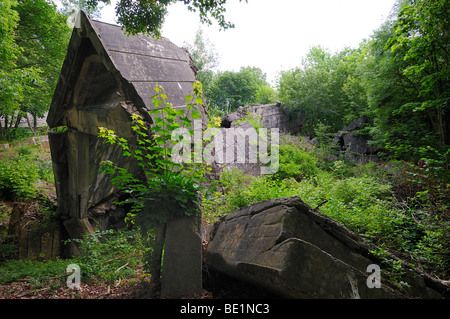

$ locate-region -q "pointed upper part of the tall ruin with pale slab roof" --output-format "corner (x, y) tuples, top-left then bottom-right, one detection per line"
(47, 12), (196, 127)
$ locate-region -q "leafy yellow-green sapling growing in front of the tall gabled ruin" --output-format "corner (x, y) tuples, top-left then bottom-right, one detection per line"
(99, 82), (208, 283)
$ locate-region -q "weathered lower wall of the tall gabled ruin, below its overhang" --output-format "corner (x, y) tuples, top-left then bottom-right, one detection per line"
(49, 117), (138, 238)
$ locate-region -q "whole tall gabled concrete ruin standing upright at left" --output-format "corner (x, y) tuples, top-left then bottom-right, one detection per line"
(47, 12), (206, 254)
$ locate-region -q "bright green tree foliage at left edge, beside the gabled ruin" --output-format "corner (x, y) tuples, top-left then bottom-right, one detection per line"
(0, 0), (70, 137)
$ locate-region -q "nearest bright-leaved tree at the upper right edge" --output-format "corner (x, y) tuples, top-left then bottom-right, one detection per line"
(387, 0), (450, 146)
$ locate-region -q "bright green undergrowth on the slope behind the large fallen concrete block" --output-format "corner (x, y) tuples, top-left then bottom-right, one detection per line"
(203, 139), (450, 278)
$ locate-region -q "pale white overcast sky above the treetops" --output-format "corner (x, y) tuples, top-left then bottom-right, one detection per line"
(100, 0), (395, 83)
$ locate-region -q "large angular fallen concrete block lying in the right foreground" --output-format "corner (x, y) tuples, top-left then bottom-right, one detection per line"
(206, 197), (448, 299)
